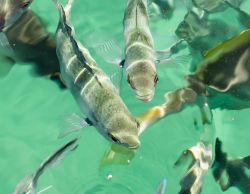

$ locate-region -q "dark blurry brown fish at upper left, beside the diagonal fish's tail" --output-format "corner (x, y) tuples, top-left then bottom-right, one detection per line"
(0, 9), (62, 86)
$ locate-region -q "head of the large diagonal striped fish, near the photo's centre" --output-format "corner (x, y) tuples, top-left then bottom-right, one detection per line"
(107, 114), (140, 149)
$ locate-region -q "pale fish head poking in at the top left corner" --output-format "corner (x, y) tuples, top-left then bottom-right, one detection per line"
(0, 0), (33, 31)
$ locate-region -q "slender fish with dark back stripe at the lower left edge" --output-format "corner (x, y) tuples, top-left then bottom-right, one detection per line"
(12, 138), (78, 194)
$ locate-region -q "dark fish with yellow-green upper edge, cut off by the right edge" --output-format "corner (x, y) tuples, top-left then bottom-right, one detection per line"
(186, 30), (250, 110)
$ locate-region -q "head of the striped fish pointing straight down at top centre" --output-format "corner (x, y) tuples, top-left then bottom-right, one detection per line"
(127, 60), (158, 102)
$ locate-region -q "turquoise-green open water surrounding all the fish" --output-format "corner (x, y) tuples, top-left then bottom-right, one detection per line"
(0, 0), (250, 194)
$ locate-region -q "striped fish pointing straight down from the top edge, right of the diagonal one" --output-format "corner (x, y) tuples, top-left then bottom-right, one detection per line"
(123, 0), (158, 101)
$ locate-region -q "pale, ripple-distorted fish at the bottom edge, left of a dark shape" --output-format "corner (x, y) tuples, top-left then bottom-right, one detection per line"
(175, 142), (212, 194)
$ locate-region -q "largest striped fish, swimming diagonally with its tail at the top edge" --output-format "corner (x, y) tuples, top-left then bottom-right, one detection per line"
(54, 0), (140, 148)
